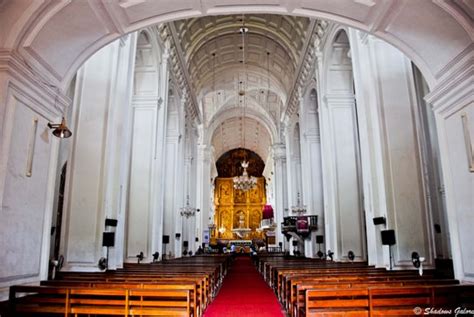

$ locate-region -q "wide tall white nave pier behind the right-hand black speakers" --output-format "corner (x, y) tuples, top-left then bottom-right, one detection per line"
(351, 32), (434, 268)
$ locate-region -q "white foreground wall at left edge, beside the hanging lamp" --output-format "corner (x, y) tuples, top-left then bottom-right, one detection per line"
(0, 75), (62, 300)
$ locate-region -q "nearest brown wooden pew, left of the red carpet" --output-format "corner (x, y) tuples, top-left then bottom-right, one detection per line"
(10, 286), (193, 317)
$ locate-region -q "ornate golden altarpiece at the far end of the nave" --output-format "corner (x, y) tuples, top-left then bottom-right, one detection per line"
(211, 177), (266, 242)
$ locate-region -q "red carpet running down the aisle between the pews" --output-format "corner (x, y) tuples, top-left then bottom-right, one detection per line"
(204, 256), (283, 317)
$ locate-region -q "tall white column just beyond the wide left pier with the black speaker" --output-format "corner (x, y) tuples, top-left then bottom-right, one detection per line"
(124, 33), (168, 262)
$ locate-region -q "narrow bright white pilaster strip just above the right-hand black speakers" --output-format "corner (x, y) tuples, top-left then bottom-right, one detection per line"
(349, 29), (388, 267)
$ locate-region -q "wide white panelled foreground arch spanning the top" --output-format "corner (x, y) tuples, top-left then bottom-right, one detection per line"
(0, 0), (474, 89)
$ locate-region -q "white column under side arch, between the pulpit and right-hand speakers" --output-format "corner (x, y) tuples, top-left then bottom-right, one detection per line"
(323, 96), (365, 260)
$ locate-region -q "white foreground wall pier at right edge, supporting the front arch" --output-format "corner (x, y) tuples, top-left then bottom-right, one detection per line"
(426, 57), (474, 282)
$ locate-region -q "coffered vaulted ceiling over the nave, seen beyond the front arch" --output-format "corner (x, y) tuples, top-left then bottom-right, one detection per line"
(168, 14), (315, 160)
